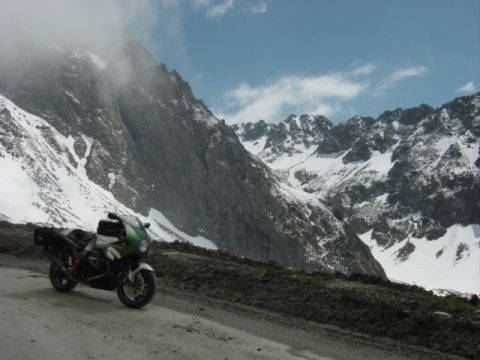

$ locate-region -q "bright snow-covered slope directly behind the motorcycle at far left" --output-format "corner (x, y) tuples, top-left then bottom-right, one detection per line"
(0, 94), (216, 248)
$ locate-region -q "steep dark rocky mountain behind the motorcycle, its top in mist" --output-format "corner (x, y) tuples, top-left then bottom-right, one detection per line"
(0, 36), (384, 276)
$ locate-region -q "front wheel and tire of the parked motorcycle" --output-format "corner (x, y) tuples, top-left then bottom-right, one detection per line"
(117, 270), (157, 309)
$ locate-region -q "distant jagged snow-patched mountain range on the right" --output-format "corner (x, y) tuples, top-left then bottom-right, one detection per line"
(235, 93), (480, 292)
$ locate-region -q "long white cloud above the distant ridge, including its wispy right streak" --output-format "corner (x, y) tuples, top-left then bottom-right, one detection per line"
(216, 63), (428, 123)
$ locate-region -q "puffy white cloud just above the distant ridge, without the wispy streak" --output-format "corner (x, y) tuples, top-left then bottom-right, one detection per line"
(219, 73), (367, 123)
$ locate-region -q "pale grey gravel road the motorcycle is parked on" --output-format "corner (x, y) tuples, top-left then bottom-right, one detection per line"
(0, 255), (464, 360)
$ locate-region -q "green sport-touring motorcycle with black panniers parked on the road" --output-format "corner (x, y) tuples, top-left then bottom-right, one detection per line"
(34, 213), (156, 309)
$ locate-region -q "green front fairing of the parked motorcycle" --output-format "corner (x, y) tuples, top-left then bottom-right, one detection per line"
(96, 216), (151, 257)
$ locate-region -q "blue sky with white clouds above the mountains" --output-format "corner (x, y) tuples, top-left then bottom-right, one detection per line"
(148, 0), (480, 123)
